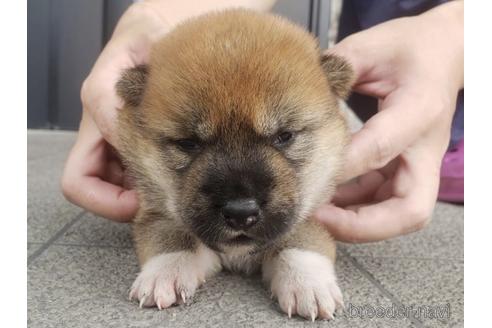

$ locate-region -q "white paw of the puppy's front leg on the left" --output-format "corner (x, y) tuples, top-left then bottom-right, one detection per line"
(130, 246), (221, 309)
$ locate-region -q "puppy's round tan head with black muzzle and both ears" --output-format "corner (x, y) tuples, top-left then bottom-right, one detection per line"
(117, 10), (352, 249)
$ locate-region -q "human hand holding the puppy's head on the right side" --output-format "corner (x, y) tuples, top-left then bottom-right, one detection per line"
(315, 1), (463, 242)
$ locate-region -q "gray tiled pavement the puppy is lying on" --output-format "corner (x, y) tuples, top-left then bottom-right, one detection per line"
(27, 131), (464, 327)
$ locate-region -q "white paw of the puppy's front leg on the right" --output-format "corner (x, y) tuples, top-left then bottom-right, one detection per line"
(263, 249), (343, 321)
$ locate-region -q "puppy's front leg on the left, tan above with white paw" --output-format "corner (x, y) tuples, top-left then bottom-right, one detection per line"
(130, 214), (221, 309)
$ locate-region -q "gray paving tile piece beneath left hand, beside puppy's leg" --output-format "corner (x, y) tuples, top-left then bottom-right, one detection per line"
(56, 214), (133, 247)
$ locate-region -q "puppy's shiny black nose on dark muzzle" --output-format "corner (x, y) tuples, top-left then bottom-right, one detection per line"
(222, 198), (260, 230)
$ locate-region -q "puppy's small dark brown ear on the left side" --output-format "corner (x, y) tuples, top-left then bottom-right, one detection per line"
(116, 65), (149, 107)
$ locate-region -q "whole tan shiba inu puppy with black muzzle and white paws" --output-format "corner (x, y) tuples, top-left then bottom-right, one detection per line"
(117, 9), (352, 320)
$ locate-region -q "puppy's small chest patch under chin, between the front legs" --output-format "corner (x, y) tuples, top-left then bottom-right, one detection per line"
(217, 247), (263, 274)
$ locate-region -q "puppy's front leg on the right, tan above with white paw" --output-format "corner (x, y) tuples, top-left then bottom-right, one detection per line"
(263, 221), (343, 321)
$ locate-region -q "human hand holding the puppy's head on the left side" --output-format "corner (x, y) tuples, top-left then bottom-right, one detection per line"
(62, 3), (172, 222)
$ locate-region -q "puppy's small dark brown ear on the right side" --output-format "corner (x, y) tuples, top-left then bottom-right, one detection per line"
(321, 54), (355, 99)
